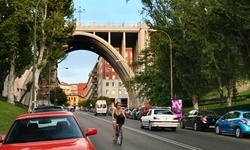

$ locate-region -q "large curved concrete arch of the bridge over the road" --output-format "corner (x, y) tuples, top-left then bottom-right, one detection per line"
(65, 31), (138, 107)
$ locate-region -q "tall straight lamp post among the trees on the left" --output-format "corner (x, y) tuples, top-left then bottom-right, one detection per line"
(32, 0), (41, 107)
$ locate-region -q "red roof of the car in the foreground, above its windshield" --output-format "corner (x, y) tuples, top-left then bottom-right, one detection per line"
(16, 111), (74, 120)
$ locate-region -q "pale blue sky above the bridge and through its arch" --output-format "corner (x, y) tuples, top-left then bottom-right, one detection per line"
(58, 0), (142, 84)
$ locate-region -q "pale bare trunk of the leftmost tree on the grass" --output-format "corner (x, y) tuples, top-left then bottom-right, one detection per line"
(8, 53), (15, 104)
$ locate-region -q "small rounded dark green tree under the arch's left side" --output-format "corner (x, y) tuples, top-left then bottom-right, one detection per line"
(50, 87), (68, 105)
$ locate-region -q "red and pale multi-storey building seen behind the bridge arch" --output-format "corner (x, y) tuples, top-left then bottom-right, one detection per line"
(87, 48), (132, 107)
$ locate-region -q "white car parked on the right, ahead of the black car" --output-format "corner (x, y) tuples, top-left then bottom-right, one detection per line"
(140, 109), (179, 131)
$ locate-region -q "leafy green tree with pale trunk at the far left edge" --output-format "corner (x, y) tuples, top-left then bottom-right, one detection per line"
(0, 0), (31, 103)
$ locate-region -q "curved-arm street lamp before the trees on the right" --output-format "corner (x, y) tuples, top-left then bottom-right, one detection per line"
(148, 29), (174, 99)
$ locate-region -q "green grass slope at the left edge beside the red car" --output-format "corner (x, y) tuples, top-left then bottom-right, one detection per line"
(0, 101), (27, 134)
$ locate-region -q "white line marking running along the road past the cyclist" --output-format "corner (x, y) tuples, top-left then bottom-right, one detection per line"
(78, 113), (202, 150)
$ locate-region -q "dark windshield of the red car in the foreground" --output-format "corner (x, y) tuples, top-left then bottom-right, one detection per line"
(5, 116), (83, 143)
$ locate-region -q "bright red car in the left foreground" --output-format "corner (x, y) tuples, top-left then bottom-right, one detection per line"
(0, 111), (97, 150)
